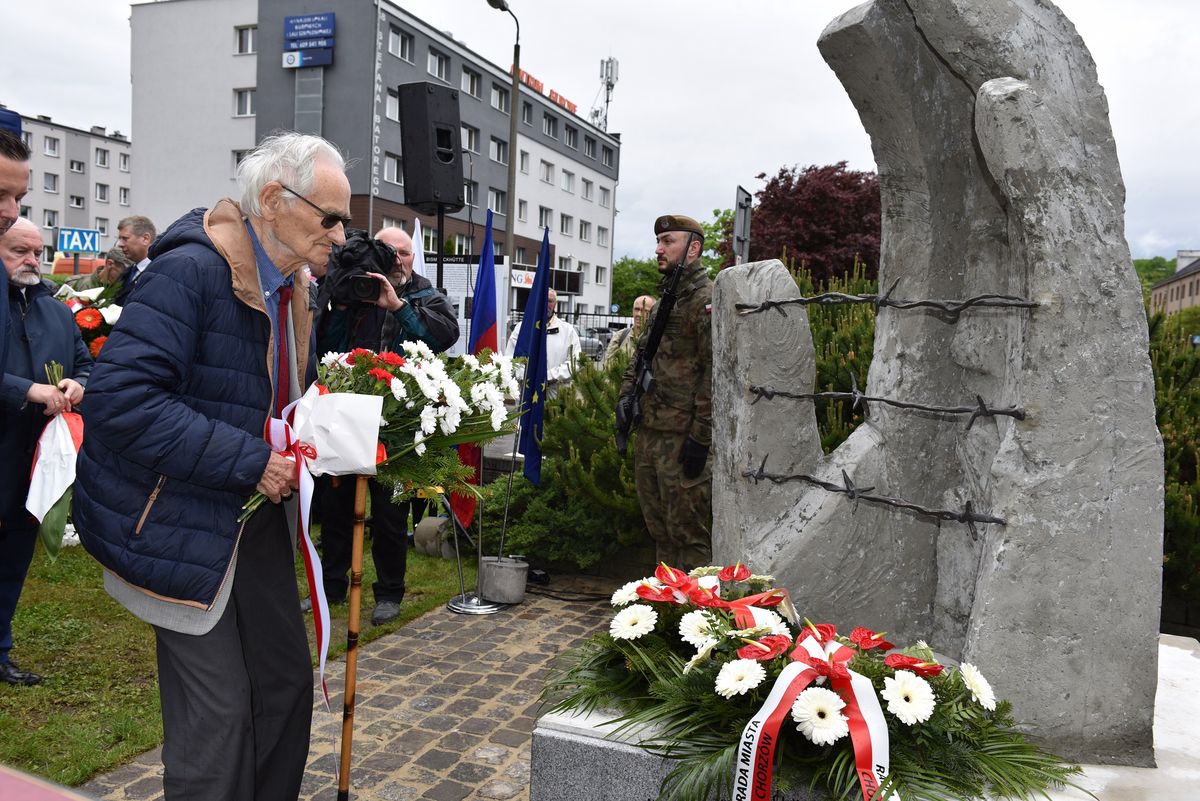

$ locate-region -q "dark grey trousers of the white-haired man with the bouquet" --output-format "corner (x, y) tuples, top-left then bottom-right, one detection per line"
(155, 504), (313, 801)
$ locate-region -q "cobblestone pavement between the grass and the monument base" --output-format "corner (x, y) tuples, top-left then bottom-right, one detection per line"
(79, 577), (613, 801)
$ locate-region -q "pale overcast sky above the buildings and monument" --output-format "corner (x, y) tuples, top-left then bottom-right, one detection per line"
(0, 0), (1200, 258)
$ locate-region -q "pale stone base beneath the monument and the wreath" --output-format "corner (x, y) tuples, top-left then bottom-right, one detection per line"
(529, 634), (1200, 801)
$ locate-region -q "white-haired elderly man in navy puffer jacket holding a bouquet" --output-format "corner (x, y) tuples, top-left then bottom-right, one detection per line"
(74, 133), (350, 801)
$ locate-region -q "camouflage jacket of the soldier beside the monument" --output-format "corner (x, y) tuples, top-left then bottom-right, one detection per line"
(622, 261), (713, 445)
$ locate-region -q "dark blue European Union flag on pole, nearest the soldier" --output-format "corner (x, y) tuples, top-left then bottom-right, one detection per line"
(512, 228), (550, 486)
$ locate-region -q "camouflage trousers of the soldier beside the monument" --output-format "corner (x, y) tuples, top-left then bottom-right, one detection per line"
(634, 428), (713, 570)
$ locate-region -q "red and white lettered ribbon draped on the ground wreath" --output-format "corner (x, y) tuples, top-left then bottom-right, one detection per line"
(733, 633), (900, 801)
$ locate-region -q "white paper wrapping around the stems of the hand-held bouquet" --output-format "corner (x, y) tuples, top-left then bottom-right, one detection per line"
(292, 386), (383, 476)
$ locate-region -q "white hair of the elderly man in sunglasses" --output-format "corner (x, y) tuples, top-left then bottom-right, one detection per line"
(238, 131), (346, 217)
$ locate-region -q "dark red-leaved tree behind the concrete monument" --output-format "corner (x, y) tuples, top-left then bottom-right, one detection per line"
(750, 162), (880, 281)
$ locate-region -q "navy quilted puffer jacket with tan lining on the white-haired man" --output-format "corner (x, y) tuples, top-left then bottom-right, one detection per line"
(73, 200), (311, 607)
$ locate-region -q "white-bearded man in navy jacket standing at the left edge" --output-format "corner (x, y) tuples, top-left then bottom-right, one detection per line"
(0, 219), (91, 685)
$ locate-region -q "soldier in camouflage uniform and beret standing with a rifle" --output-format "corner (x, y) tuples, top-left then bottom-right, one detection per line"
(622, 215), (713, 570)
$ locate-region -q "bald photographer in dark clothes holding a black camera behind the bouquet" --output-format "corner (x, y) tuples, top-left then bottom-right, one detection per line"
(314, 228), (458, 625)
